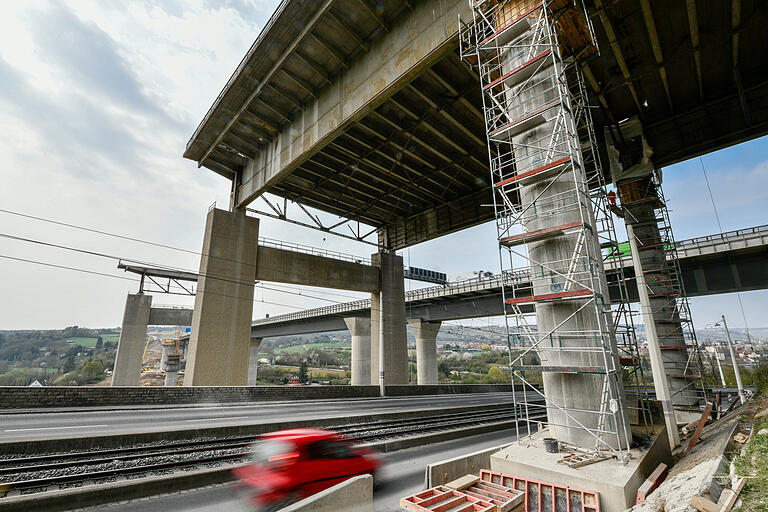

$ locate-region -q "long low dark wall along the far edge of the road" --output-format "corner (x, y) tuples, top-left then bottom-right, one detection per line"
(0, 384), (512, 409)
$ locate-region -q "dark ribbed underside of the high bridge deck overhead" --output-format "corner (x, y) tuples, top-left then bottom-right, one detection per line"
(185, 0), (768, 249)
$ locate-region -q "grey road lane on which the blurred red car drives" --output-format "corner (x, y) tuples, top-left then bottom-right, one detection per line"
(80, 431), (515, 512)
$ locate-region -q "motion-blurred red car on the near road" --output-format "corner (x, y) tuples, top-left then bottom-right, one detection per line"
(232, 428), (382, 510)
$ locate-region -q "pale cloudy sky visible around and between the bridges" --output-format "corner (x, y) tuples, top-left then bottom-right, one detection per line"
(0, 0), (768, 329)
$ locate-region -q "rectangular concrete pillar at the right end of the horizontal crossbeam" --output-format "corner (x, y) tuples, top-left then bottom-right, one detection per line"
(371, 252), (408, 385)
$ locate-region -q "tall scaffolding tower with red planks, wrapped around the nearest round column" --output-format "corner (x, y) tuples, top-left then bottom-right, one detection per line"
(460, 0), (639, 459)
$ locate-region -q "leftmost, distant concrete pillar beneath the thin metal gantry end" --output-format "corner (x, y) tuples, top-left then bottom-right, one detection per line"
(112, 293), (152, 386)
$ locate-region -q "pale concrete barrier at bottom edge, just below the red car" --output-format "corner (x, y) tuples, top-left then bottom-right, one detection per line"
(280, 475), (373, 512)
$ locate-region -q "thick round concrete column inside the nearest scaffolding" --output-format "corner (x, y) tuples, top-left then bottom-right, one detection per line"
(500, 15), (631, 448)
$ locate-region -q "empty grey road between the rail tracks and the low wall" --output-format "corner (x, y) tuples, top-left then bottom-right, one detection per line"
(0, 393), (512, 442)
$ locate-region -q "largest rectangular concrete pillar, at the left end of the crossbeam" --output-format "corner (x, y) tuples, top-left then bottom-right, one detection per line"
(184, 209), (259, 386)
